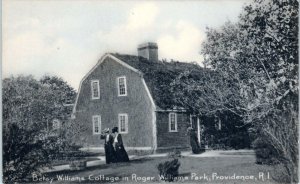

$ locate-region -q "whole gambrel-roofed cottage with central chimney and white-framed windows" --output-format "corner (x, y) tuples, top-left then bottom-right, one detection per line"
(73, 43), (203, 151)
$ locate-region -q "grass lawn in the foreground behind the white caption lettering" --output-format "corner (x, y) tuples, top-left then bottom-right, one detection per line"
(34, 150), (282, 183)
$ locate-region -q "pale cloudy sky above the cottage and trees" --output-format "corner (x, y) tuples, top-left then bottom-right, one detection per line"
(2, 0), (247, 90)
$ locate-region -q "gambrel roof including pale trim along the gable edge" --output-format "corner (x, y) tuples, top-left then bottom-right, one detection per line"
(72, 53), (204, 117)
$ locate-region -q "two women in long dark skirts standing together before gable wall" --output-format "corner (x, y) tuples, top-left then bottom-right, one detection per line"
(101, 127), (129, 164)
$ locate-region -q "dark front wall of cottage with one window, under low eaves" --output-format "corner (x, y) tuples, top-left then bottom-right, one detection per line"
(156, 112), (190, 149)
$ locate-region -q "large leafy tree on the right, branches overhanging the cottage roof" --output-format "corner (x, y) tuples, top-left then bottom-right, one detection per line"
(173, 0), (299, 182)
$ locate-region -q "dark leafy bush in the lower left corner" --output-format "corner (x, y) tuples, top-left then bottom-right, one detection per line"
(3, 123), (59, 183)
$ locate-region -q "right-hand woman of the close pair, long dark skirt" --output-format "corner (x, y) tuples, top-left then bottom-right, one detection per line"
(112, 127), (129, 162)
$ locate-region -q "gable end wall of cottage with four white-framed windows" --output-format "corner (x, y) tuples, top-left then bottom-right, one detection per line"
(75, 57), (153, 147)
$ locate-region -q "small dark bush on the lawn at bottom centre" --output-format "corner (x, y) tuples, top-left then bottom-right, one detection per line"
(157, 159), (180, 182)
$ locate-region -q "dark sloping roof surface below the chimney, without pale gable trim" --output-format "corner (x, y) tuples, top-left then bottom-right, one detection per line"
(111, 53), (203, 109)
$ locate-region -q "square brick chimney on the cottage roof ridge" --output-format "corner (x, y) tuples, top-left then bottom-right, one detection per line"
(138, 42), (158, 62)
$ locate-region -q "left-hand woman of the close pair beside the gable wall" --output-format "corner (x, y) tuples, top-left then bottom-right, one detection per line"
(101, 128), (117, 164)
